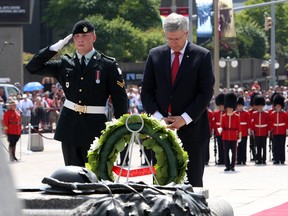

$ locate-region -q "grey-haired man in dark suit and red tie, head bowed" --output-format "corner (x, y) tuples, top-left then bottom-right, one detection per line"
(141, 13), (215, 187)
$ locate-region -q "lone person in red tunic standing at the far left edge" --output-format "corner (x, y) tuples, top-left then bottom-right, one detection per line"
(3, 100), (21, 162)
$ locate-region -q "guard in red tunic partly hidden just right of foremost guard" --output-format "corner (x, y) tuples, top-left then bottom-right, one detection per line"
(236, 96), (251, 165)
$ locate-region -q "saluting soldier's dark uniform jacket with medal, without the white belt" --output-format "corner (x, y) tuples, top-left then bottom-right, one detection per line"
(26, 47), (128, 146)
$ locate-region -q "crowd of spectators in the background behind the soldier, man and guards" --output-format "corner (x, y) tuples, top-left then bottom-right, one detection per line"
(0, 78), (288, 133)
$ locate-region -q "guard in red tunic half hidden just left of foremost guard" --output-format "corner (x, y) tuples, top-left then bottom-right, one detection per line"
(213, 93), (226, 165)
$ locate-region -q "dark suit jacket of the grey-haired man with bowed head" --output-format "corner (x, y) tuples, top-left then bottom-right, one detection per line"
(141, 42), (215, 141)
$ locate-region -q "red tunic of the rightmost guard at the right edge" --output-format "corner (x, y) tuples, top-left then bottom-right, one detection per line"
(270, 110), (288, 135)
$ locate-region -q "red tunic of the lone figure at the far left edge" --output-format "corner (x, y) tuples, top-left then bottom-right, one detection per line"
(3, 110), (21, 135)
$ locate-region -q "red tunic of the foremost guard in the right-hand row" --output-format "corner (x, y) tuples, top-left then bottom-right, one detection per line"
(221, 112), (241, 141)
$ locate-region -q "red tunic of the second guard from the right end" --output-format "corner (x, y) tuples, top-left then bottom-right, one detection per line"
(251, 111), (270, 136)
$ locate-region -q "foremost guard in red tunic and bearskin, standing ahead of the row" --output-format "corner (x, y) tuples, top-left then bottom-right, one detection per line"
(220, 92), (241, 171)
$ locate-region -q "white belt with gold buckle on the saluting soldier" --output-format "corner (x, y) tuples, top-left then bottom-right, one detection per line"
(63, 99), (106, 114)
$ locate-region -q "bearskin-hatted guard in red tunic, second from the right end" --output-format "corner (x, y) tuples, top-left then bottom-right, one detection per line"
(251, 95), (270, 164)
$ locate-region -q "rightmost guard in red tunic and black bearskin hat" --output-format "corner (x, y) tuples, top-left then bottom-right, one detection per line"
(270, 94), (288, 164)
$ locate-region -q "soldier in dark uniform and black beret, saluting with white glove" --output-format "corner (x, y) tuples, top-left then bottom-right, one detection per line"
(26, 20), (128, 166)
